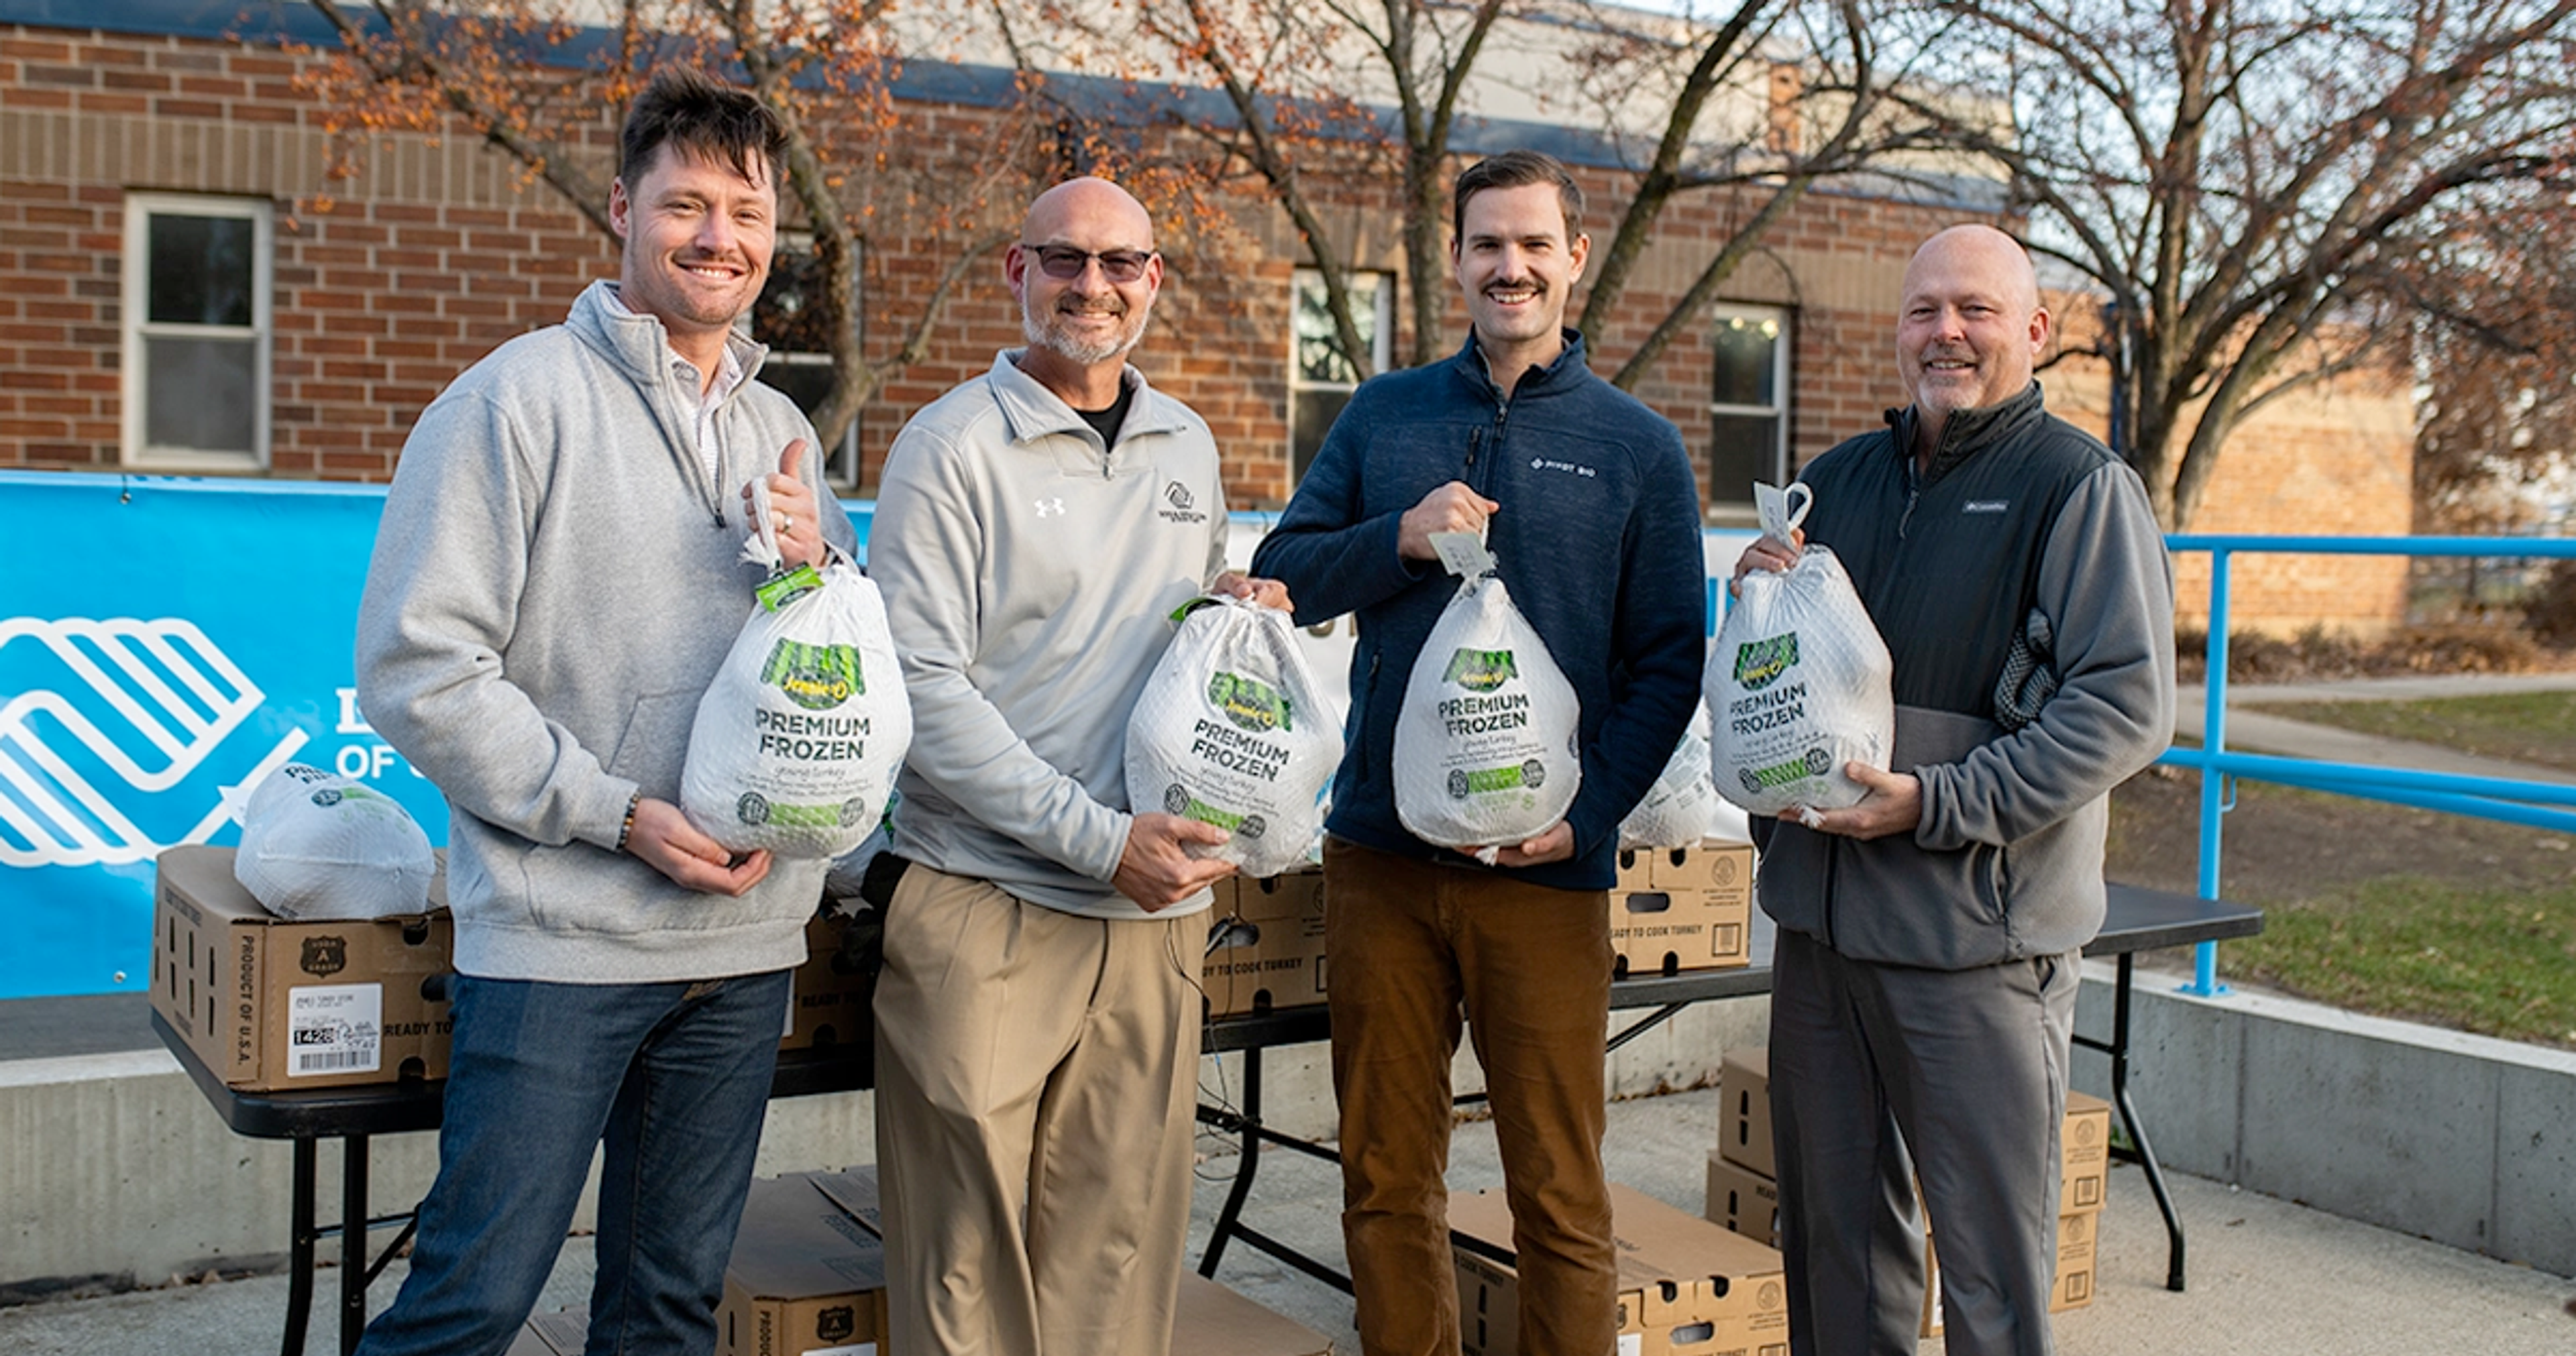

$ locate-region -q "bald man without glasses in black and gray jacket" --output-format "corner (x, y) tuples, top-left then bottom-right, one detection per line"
(1736, 227), (2174, 1356)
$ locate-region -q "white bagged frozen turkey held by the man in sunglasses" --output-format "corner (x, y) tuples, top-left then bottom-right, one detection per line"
(1126, 597), (1342, 875)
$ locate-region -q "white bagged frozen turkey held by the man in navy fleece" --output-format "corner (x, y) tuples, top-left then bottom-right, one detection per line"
(1393, 571), (1585, 849)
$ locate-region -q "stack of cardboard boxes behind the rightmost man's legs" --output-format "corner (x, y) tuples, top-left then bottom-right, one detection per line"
(1708, 1050), (2110, 1338)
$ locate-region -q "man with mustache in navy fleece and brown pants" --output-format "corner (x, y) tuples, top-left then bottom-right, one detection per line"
(1252, 152), (1705, 1356)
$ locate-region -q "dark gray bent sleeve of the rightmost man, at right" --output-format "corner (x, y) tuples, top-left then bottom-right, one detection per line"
(1911, 463), (2174, 852)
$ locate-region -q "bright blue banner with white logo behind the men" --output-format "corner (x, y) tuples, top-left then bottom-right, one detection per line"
(0, 471), (1752, 999)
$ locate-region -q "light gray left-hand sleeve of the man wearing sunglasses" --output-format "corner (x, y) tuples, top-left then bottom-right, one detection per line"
(868, 427), (1133, 883)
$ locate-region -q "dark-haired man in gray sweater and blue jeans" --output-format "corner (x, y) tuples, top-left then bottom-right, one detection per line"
(358, 72), (850, 1356)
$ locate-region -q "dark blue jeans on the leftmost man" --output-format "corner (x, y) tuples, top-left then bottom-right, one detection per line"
(358, 970), (788, 1356)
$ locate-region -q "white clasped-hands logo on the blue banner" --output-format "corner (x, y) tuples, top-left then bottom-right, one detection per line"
(0, 618), (307, 867)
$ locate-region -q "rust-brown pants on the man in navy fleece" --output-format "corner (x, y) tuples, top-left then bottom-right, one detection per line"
(1324, 839), (1618, 1356)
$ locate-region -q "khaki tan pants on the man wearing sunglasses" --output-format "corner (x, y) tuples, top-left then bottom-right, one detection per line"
(876, 864), (1208, 1356)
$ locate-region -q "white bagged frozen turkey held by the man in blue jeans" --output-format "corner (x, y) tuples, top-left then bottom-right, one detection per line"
(680, 481), (912, 859)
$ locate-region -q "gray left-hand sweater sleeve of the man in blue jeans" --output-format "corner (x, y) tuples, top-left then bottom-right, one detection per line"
(358, 391), (636, 846)
